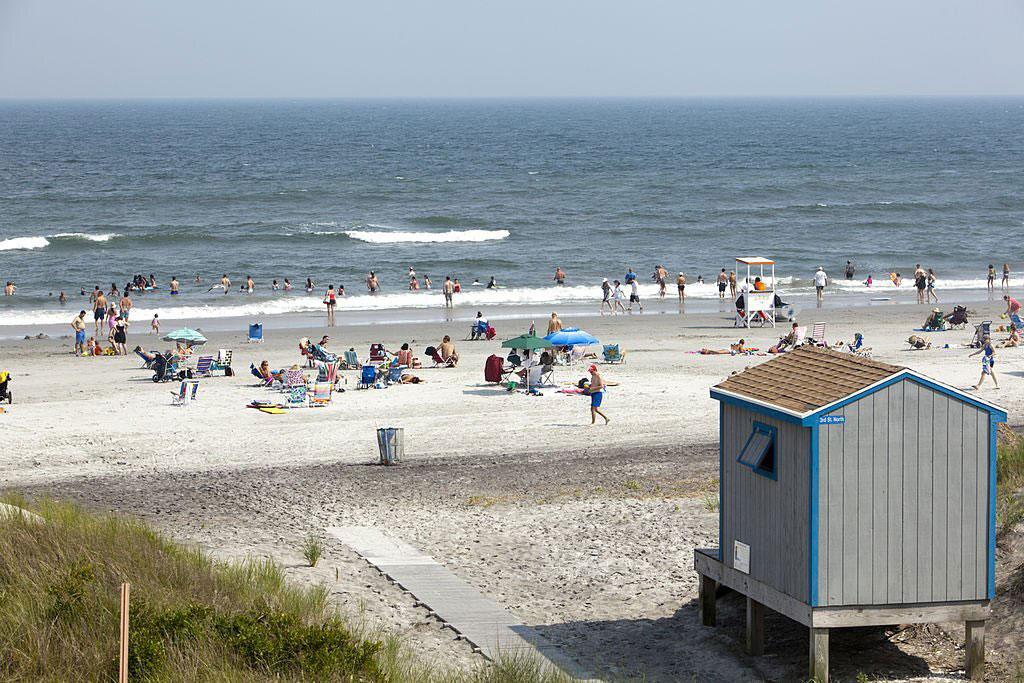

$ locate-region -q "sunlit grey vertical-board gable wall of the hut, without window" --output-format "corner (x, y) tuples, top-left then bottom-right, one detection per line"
(818, 380), (989, 605)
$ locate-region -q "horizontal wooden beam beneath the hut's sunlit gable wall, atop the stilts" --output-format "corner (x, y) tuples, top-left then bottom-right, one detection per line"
(811, 600), (990, 629)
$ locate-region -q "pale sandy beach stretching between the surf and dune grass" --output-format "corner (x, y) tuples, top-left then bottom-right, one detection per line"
(0, 294), (1024, 681)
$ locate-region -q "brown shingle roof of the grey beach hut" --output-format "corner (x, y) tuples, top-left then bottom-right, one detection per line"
(715, 346), (905, 414)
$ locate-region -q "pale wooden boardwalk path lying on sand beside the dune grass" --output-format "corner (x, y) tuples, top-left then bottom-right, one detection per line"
(327, 526), (593, 680)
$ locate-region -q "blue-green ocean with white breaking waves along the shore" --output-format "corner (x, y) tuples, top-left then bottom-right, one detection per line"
(0, 99), (1024, 326)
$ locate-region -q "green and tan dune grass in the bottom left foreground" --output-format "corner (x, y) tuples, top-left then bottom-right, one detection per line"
(0, 496), (569, 683)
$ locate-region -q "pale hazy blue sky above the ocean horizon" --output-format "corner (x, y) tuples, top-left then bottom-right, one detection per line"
(0, 0), (1024, 98)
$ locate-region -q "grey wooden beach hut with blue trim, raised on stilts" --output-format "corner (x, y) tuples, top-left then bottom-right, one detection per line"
(694, 347), (1007, 682)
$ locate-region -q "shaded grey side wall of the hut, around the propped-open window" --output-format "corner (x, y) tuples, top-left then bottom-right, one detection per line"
(720, 404), (811, 601)
